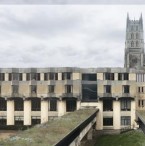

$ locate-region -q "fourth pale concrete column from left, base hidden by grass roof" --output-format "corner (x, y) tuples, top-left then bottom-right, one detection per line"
(57, 100), (66, 116)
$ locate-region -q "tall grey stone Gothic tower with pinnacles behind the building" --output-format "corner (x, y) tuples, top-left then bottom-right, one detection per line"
(124, 14), (144, 69)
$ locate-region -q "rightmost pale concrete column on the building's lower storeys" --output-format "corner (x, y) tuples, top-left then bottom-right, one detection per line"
(131, 100), (137, 128)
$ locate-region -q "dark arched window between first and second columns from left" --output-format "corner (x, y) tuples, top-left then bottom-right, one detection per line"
(14, 98), (24, 111)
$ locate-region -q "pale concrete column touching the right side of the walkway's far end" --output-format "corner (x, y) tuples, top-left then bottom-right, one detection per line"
(96, 101), (103, 130)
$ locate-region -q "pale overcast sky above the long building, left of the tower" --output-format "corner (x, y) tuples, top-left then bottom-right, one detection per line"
(0, 5), (145, 67)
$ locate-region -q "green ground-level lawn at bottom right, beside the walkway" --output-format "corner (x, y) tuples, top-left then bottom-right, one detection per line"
(94, 130), (145, 146)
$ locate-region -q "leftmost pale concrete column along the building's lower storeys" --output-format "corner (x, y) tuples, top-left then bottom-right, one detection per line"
(7, 100), (14, 125)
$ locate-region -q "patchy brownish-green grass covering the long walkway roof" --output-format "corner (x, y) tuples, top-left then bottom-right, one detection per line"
(0, 109), (96, 146)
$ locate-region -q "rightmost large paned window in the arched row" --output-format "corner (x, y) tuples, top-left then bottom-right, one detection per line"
(121, 99), (131, 111)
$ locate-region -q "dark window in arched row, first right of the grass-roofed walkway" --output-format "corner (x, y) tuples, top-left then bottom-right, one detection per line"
(103, 99), (113, 111)
